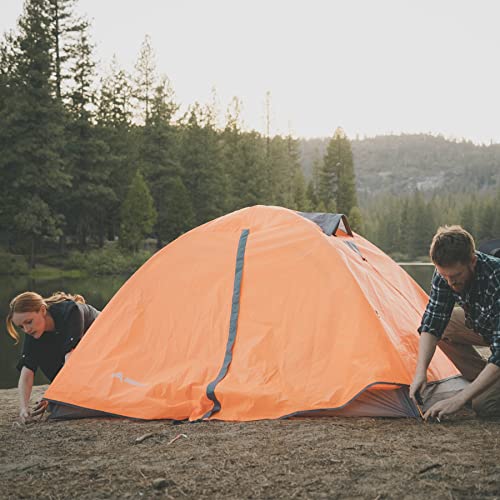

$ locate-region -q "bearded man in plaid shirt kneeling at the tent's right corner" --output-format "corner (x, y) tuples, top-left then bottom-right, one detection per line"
(410, 226), (500, 419)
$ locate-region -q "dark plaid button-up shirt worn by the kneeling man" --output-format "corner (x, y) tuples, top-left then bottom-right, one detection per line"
(418, 252), (500, 367)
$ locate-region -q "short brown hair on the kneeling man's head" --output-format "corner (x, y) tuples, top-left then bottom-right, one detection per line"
(429, 226), (476, 267)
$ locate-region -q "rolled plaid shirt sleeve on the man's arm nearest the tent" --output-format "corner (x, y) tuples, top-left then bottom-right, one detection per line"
(418, 271), (455, 339)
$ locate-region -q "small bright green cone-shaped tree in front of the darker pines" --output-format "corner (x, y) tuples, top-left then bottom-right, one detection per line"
(120, 170), (157, 252)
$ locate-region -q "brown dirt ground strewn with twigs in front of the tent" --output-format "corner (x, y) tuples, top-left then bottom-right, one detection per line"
(0, 387), (500, 499)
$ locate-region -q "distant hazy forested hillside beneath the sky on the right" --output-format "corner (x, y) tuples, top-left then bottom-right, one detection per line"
(300, 134), (500, 196)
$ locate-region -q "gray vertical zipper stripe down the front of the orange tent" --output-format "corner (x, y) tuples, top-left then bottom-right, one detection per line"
(203, 229), (250, 418)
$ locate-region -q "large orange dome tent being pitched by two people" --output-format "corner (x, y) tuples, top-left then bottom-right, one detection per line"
(45, 206), (464, 421)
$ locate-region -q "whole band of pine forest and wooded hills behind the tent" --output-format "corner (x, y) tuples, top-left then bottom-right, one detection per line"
(0, 0), (500, 272)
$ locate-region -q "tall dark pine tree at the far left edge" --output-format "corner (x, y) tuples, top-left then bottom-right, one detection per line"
(0, 0), (71, 262)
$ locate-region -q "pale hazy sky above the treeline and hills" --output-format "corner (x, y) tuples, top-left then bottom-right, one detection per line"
(0, 0), (500, 142)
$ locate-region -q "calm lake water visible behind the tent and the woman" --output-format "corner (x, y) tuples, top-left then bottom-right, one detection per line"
(0, 265), (434, 389)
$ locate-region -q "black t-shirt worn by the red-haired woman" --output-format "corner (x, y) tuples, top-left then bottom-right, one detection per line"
(17, 300), (99, 382)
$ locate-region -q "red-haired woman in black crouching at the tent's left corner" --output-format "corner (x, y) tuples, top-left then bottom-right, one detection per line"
(6, 292), (99, 423)
